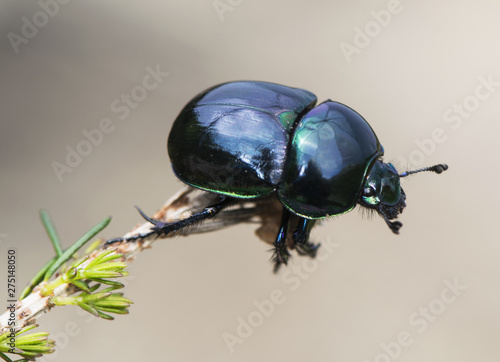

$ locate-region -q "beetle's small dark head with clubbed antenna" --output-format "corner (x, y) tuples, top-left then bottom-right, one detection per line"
(358, 160), (448, 234)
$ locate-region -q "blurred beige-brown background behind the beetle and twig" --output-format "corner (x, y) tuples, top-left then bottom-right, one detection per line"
(0, 0), (500, 362)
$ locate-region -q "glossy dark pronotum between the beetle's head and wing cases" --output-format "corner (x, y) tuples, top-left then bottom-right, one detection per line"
(278, 101), (383, 218)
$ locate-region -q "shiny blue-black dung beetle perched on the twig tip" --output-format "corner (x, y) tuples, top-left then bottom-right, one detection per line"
(107, 81), (448, 270)
